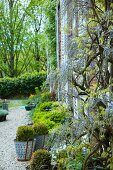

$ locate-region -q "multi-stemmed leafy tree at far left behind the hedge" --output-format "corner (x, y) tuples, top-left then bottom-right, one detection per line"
(0, 0), (27, 77)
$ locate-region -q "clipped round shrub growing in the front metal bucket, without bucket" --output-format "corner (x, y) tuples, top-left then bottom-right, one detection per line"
(16, 125), (35, 141)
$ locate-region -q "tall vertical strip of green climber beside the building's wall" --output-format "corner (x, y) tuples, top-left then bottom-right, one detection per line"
(45, 0), (56, 68)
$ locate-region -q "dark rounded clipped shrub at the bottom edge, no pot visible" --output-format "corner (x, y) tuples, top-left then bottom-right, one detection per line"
(30, 149), (51, 170)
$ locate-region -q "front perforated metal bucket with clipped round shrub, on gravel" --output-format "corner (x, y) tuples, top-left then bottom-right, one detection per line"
(14, 125), (35, 161)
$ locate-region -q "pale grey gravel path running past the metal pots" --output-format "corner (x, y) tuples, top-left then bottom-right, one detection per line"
(0, 107), (30, 170)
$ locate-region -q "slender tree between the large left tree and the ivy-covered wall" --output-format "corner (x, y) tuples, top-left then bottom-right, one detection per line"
(28, 1), (45, 72)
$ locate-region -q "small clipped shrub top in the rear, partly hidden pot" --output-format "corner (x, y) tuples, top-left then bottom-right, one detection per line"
(33, 123), (49, 135)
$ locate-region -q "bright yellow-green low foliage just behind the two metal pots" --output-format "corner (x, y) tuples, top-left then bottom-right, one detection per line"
(32, 102), (66, 130)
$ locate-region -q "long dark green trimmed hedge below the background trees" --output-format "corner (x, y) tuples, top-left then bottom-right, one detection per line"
(0, 72), (46, 99)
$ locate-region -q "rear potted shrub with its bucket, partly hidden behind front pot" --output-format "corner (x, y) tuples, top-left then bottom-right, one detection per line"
(33, 123), (49, 151)
